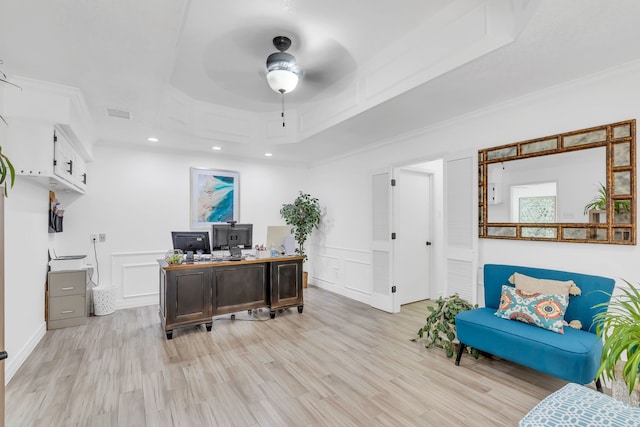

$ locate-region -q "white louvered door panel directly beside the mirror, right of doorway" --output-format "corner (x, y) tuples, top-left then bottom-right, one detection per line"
(444, 153), (478, 304)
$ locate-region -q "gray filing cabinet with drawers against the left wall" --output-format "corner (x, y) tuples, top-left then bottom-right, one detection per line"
(47, 270), (87, 329)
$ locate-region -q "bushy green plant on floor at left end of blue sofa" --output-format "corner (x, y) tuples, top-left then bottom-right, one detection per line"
(412, 294), (478, 359)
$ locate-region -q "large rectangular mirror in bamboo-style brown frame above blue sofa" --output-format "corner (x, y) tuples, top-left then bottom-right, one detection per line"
(478, 119), (636, 245)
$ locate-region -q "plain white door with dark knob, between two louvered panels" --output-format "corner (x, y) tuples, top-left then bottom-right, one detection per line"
(393, 168), (431, 305)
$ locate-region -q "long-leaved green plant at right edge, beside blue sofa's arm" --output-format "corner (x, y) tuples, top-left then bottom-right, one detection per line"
(594, 280), (640, 394)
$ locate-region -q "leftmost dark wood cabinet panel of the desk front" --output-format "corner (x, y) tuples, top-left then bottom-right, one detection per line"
(166, 268), (211, 324)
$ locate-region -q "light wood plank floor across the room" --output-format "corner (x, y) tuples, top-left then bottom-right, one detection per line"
(6, 287), (576, 427)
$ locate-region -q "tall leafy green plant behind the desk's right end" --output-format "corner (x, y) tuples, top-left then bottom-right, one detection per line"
(280, 191), (321, 260)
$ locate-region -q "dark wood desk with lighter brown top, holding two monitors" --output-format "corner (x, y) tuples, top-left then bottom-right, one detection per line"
(158, 256), (304, 339)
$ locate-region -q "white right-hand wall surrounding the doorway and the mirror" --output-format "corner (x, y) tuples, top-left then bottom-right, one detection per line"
(304, 62), (640, 302)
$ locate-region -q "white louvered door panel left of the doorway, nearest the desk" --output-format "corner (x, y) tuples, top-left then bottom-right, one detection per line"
(371, 170), (400, 313)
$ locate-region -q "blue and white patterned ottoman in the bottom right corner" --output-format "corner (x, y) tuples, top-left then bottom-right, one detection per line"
(518, 383), (640, 427)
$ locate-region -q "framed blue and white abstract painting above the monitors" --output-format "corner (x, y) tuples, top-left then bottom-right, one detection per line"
(191, 168), (239, 228)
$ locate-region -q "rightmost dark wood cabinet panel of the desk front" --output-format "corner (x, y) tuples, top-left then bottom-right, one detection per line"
(271, 260), (303, 309)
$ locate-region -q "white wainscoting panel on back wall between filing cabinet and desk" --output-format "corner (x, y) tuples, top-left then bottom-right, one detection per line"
(111, 251), (166, 309)
